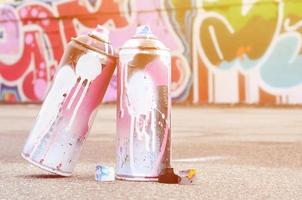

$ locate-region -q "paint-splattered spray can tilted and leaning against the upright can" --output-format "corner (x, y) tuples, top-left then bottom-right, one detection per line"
(22, 26), (117, 176)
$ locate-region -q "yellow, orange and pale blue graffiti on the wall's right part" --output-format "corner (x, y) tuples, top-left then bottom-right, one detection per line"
(166, 0), (302, 105)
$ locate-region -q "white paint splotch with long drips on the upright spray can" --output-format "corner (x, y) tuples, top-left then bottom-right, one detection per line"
(119, 60), (163, 171)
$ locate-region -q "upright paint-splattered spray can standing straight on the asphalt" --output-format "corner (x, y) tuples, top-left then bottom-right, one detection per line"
(116, 26), (171, 181)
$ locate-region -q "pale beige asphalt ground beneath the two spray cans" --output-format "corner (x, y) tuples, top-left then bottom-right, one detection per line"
(0, 105), (302, 200)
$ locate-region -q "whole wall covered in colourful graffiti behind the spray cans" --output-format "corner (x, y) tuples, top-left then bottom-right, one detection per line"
(0, 0), (302, 105)
